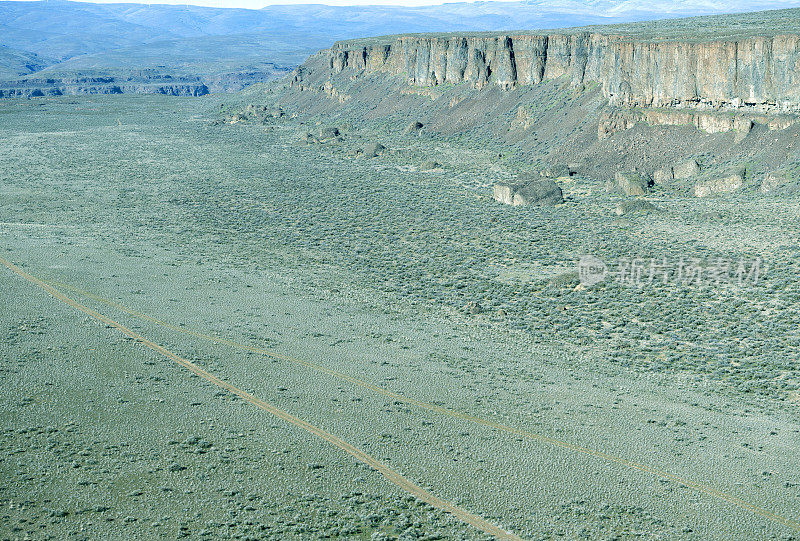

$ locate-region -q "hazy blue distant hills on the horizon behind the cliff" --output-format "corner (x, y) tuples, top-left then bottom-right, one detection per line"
(0, 0), (800, 95)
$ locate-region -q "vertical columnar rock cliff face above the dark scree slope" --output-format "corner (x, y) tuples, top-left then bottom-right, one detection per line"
(327, 32), (800, 113)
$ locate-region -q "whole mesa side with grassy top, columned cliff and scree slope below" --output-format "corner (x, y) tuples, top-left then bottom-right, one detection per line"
(268, 10), (800, 191)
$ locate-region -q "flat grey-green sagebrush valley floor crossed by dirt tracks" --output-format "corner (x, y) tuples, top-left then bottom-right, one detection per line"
(0, 96), (800, 539)
